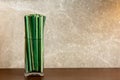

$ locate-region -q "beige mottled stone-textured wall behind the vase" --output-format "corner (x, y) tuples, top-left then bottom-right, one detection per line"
(0, 0), (120, 68)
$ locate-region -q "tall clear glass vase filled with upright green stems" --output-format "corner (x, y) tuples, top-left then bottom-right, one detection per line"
(24, 14), (46, 76)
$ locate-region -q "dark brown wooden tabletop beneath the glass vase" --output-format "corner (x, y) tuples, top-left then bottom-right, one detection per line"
(0, 68), (120, 80)
